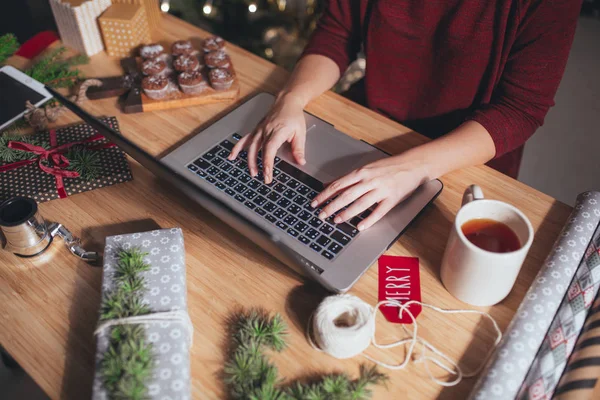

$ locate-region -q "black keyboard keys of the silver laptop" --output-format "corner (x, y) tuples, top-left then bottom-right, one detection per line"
(187, 133), (371, 260)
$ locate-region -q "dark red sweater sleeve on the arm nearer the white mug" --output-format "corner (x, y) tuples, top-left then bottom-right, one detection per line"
(467, 0), (581, 157)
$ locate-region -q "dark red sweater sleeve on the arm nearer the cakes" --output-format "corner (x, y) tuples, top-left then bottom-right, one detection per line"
(302, 0), (360, 76)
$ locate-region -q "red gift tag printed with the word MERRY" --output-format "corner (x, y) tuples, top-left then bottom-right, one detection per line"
(379, 256), (421, 324)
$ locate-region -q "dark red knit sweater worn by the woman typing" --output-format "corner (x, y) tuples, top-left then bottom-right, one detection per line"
(304, 0), (581, 177)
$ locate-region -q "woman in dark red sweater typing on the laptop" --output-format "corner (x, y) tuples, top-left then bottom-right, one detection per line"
(230, 0), (581, 230)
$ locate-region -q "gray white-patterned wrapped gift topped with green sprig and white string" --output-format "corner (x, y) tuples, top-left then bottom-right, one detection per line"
(92, 228), (193, 400)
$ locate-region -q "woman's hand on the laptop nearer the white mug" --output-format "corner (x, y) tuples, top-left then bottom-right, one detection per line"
(311, 154), (429, 231)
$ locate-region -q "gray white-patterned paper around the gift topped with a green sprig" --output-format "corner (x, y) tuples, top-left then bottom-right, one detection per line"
(92, 228), (191, 400)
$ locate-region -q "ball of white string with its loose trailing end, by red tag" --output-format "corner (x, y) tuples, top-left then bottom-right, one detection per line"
(306, 294), (502, 386)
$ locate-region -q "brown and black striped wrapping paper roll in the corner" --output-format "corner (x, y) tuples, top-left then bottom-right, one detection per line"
(554, 296), (600, 400)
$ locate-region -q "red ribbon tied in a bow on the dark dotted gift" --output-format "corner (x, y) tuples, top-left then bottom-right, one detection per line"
(0, 129), (115, 199)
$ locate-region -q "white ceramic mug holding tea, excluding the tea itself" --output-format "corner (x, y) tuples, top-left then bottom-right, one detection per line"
(441, 185), (533, 306)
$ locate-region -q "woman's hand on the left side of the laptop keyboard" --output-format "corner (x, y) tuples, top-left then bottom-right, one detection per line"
(229, 93), (306, 184)
